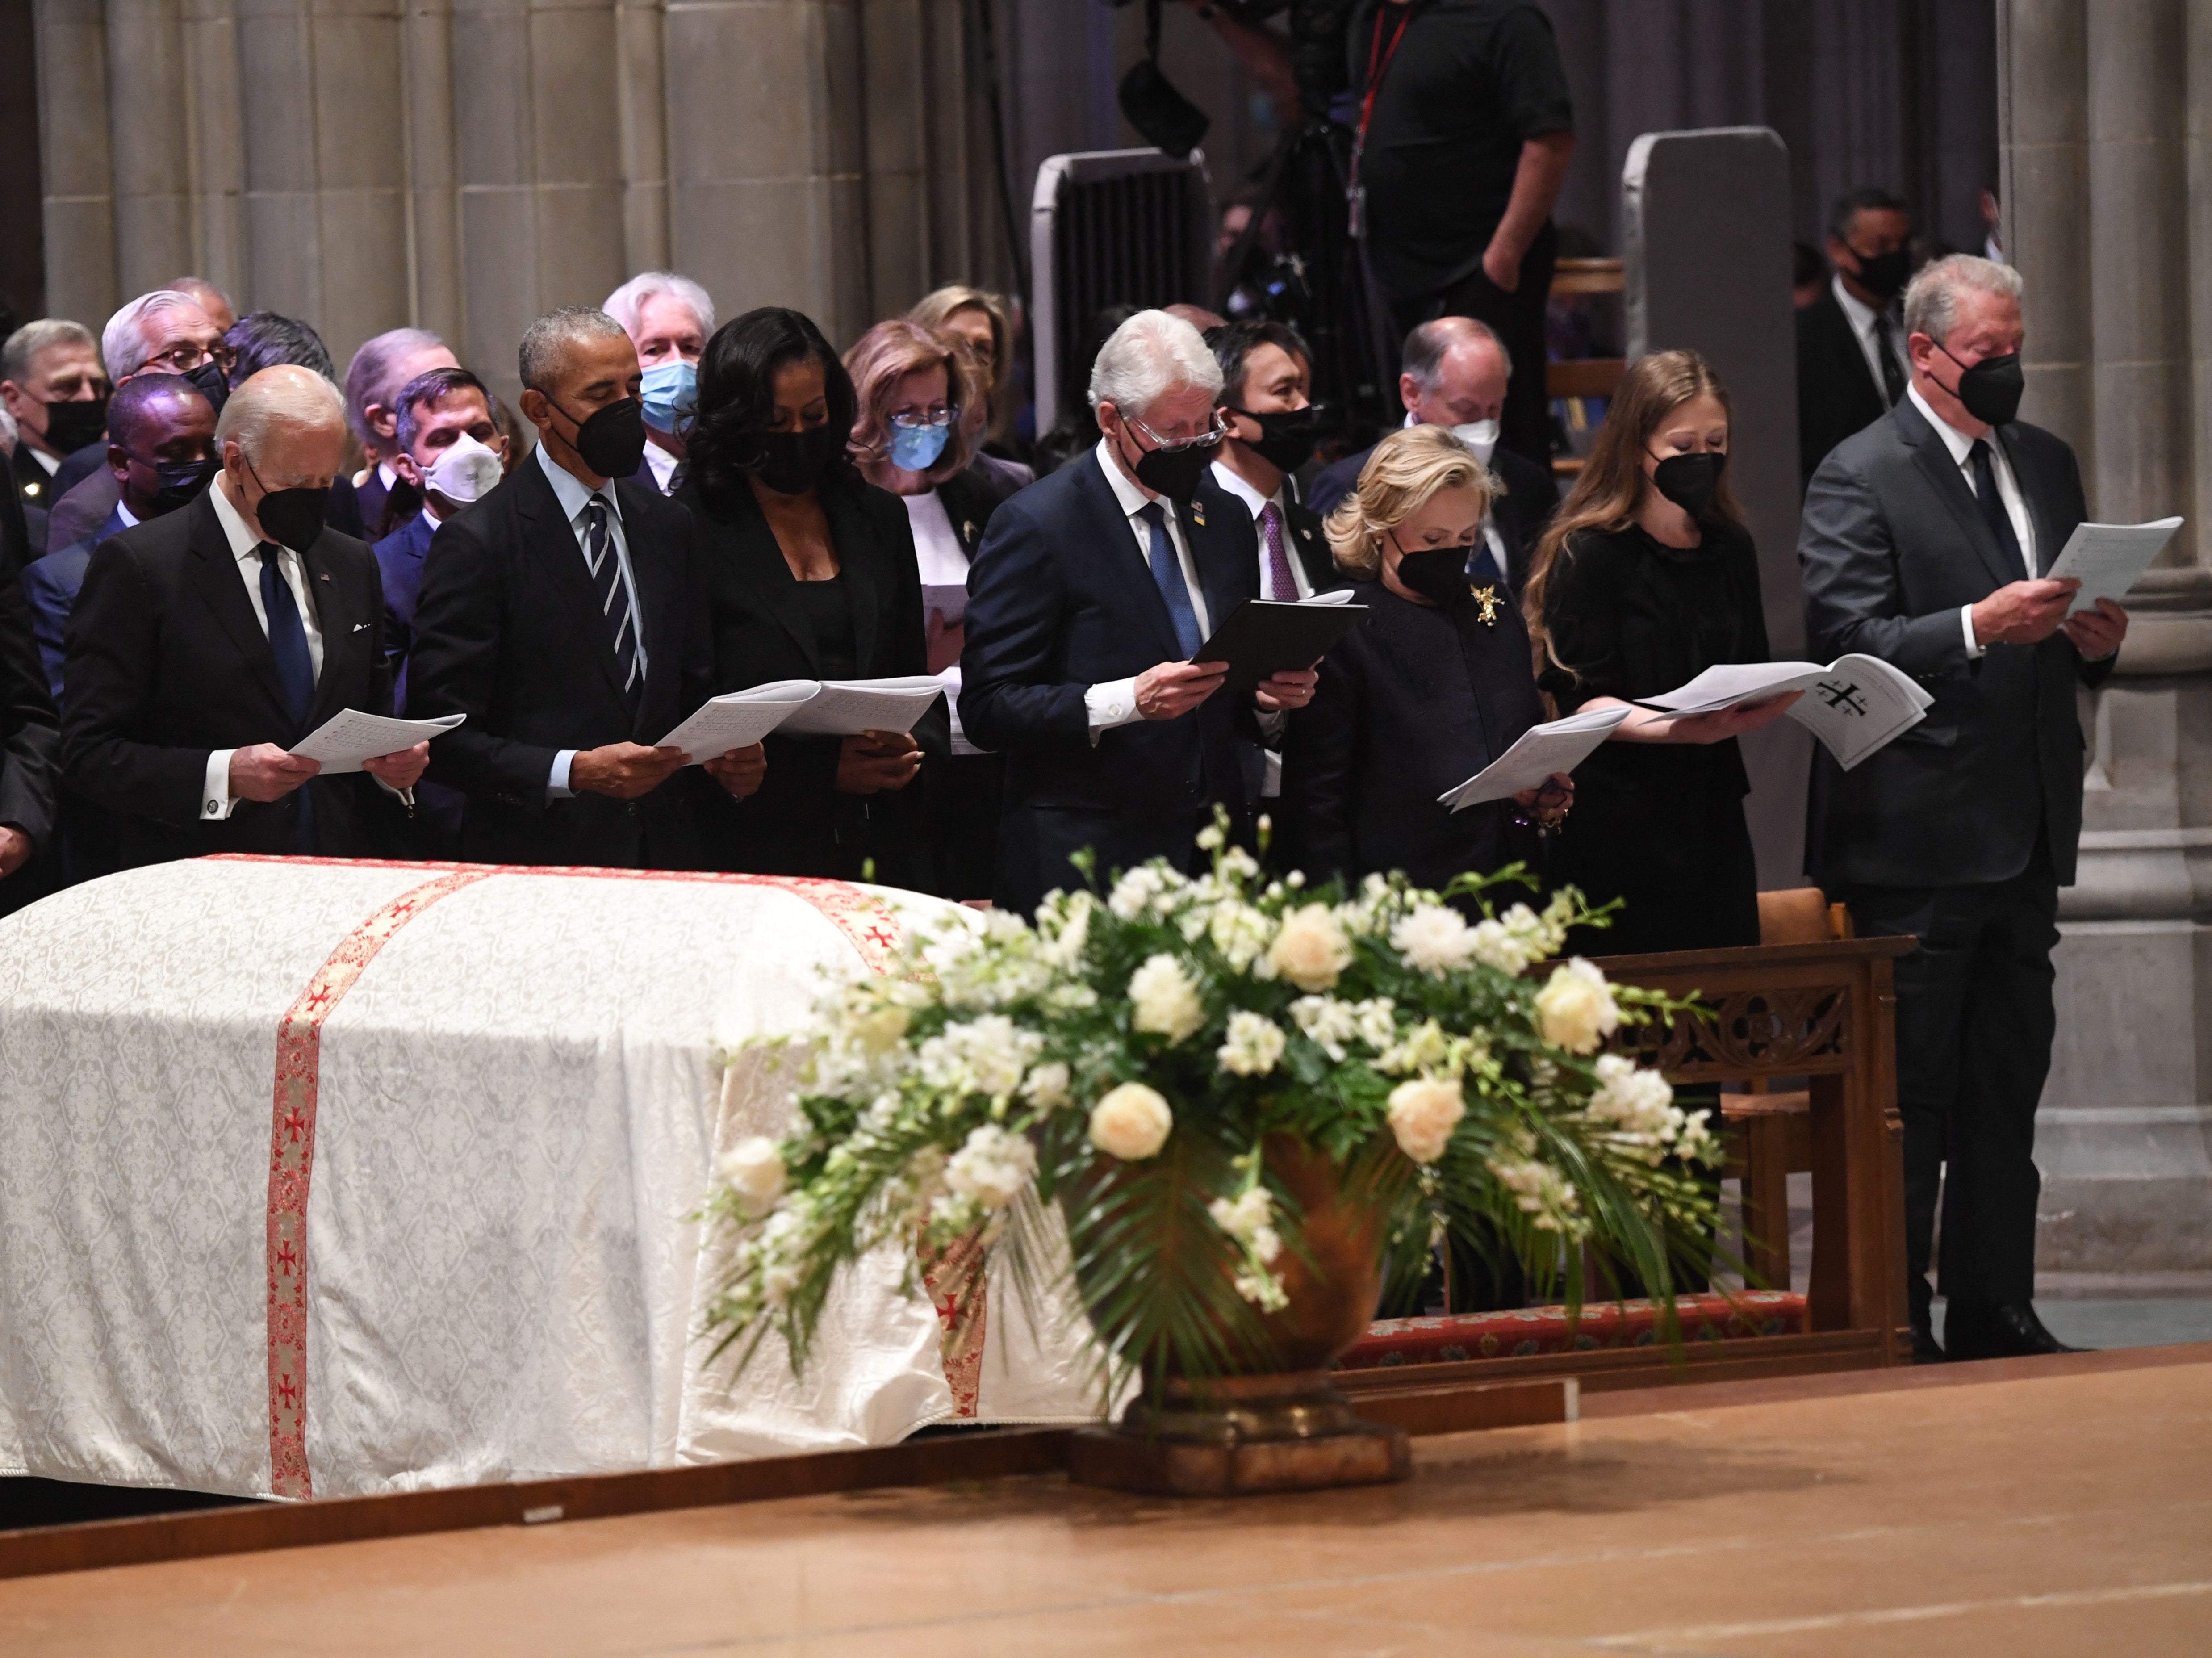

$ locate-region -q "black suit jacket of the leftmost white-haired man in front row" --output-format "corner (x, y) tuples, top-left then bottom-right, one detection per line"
(62, 485), (400, 868)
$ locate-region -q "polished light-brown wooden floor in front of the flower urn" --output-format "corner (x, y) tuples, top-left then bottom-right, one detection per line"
(0, 1348), (2212, 1658)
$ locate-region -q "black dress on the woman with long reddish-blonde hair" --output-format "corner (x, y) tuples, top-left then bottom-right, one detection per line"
(1542, 525), (1769, 956)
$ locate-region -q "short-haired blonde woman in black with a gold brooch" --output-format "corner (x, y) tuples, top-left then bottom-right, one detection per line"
(1281, 425), (1573, 888)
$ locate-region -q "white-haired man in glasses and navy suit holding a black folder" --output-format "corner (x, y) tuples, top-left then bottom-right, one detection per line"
(960, 310), (1314, 914)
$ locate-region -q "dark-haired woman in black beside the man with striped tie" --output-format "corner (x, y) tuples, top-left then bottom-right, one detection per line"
(677, 308), (947, 888)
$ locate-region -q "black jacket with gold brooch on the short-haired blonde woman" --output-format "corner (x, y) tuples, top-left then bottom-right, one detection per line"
(1281, 580), (1544, 888)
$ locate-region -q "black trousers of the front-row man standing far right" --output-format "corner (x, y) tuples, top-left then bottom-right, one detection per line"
(1843, 846), (2059, 1324)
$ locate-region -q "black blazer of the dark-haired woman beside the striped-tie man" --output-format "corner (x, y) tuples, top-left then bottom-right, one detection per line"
(677, 469), (951, 885)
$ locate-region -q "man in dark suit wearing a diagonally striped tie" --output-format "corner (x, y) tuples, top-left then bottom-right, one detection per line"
(407, 306), (765, 870)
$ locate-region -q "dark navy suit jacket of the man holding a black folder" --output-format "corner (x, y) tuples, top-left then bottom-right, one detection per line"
(960, 454), (1259, 914)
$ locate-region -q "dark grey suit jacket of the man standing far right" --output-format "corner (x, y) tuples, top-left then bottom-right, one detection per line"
(1798, 401), (2112, 888)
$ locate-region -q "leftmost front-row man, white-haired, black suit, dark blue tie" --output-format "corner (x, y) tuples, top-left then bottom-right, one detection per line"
(62, 368), (429, 868)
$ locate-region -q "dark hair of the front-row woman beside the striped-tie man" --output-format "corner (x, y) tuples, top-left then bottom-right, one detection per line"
(683, 306), (861, 511)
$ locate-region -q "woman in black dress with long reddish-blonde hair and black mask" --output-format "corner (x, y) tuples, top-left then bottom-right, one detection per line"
(1522, 352), (1796, 954)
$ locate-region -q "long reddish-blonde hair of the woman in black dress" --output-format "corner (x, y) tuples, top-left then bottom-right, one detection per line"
(1522, 350), (1743, 673)
